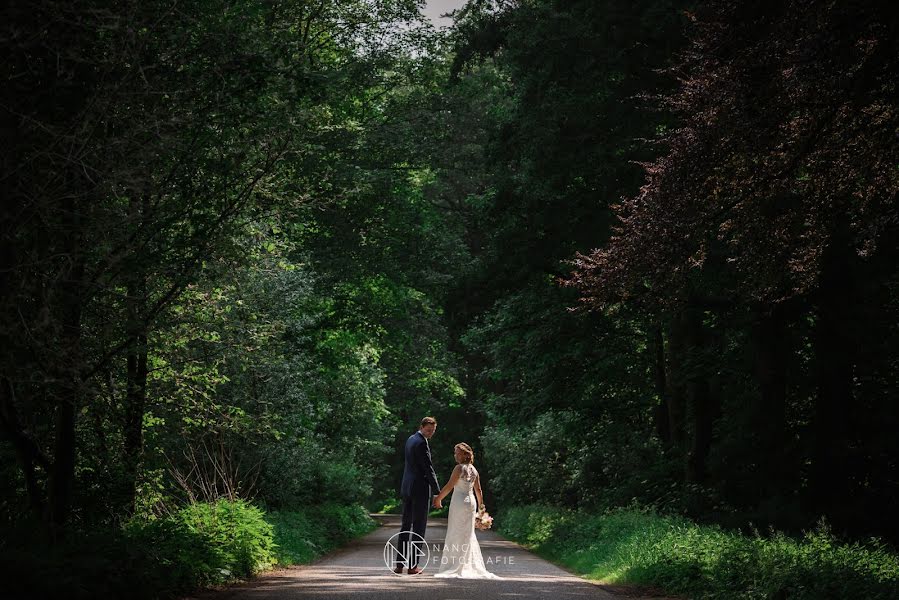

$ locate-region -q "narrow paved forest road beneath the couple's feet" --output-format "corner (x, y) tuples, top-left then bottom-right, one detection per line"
(190, 515), (676, 600)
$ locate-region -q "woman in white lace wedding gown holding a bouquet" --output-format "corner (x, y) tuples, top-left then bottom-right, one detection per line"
(434, 443), (502, 579)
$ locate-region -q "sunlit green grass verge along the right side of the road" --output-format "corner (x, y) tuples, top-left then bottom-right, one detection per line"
(497, 505), (899, 600)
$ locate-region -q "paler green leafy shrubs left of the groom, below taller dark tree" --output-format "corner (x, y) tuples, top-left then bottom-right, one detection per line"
(136, 237), (389, 511)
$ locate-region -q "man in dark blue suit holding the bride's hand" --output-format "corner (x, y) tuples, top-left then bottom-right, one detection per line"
(393, 417), (440, 575)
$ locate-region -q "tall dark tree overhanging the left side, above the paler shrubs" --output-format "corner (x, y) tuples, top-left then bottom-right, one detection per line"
(0, 1), (428, 529)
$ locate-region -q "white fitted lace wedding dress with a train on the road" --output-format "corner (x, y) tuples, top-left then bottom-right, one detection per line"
(434, 464), (502, 579)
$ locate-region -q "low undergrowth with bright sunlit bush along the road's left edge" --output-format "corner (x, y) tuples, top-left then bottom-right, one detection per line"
(0, 500), (377, 600)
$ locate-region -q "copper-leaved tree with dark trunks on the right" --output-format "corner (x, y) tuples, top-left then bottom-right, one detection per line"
(568, 1), (899, 536)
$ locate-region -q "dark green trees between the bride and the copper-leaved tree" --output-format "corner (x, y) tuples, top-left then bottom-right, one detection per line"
(425, 0), (682, 507)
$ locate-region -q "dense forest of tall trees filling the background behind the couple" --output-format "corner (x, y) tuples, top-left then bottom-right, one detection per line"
(0, 0), (899, 597)
